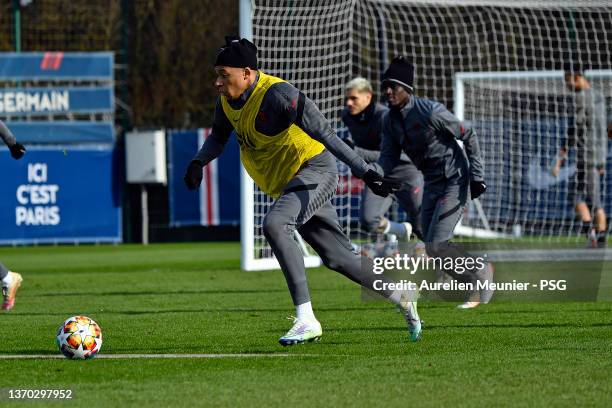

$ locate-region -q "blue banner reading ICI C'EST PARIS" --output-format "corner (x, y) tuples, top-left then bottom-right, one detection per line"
(0, 145), (122, 245)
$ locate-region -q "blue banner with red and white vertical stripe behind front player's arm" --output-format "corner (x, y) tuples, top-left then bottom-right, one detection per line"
(167, 129), (240, 227)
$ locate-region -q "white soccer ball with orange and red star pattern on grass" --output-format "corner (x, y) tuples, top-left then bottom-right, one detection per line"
(55, 316), (102, 360)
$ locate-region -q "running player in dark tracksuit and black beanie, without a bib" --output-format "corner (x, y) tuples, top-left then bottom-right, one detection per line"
(379, 57), (492, 308)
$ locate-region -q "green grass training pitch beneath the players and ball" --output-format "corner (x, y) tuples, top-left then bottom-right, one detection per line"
(0, 243), (612, 407)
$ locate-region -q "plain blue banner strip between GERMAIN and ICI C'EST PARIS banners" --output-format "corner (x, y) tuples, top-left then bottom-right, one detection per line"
(5, 121), (115, 144)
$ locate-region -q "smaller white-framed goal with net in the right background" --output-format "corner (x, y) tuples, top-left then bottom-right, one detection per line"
(455, 70), (612, 239)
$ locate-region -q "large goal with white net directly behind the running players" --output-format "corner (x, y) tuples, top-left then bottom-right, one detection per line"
(241, 0), (612, 269)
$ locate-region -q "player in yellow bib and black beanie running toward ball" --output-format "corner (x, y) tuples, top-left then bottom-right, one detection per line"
(185, 37), (421, 346)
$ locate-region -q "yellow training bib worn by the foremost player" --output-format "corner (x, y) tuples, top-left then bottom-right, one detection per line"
(221, 71), (325, 197)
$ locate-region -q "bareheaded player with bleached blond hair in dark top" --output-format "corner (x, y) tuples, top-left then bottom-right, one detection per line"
(341, 77), (423, 240)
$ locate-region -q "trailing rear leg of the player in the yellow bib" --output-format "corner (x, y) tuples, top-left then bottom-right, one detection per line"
(299, 201), (421, 341)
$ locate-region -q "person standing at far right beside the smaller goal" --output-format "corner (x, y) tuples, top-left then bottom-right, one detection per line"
(553, 66), (608, 247)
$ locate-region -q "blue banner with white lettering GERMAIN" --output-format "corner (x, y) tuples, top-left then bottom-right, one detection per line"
(0, 86), (114, 116)
